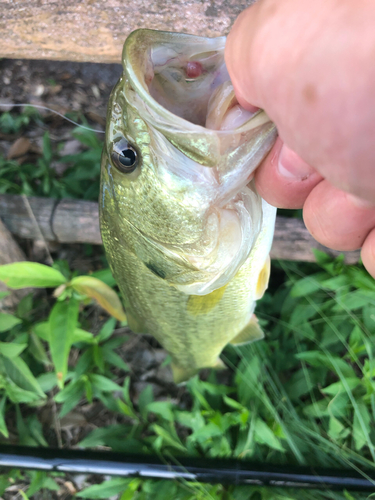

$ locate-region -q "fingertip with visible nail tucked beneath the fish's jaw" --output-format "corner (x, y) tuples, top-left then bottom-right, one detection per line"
(255, 138), (322, 208)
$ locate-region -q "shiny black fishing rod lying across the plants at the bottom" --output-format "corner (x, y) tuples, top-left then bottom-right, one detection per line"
(0, 445), (375, 492)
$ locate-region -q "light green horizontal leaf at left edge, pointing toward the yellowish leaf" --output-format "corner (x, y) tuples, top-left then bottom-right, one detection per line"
(0, 262), (66, 289)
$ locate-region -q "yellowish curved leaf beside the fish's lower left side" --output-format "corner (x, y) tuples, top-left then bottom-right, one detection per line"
(70, 276), (126, 321)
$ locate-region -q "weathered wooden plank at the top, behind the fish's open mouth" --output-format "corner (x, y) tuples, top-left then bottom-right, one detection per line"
(0, 0), (252, 62)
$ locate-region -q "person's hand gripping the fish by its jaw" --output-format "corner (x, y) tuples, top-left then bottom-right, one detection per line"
(225, 0), (375, 277)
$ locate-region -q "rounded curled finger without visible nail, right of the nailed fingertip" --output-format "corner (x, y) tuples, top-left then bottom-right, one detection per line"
(303, 180), (375, 251)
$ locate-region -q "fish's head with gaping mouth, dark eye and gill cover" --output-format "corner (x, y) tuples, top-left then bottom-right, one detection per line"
(101, 30), (276, 295)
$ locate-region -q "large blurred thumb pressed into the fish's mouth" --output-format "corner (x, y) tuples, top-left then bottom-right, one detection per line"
(225, 0), (375, 203)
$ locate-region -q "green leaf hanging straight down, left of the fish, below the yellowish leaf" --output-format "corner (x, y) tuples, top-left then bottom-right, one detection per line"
(49, 299), (79, 388)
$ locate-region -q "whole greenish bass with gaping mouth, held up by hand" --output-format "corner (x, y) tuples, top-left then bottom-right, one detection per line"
(99, 29), (277, 383)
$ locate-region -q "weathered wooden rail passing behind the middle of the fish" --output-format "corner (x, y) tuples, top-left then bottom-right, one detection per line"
(0, 194), (359, 264)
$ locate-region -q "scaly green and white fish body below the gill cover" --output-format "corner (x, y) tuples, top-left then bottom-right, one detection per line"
(102, 219), (255, 379)
